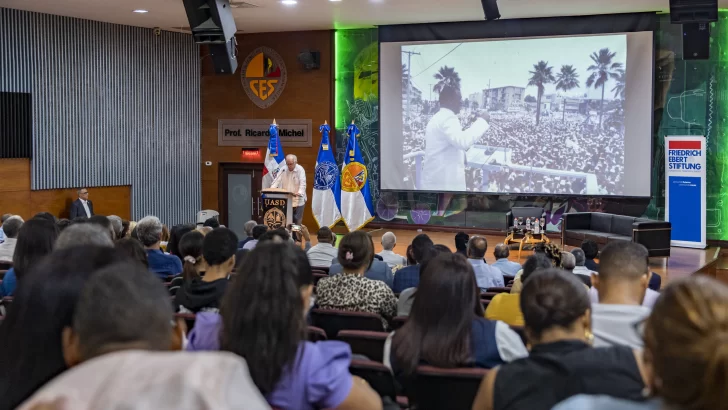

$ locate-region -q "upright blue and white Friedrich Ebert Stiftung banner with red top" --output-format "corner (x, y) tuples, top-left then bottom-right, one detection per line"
(665, 136), (707, 248)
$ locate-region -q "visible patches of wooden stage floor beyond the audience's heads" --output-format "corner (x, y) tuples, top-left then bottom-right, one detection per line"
(356, 229), (720, 286)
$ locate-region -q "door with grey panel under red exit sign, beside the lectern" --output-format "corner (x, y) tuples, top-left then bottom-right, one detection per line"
(218, 163), (263, 239)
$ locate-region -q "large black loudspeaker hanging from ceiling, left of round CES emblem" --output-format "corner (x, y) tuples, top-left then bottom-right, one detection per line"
(184, 0), (238, 74)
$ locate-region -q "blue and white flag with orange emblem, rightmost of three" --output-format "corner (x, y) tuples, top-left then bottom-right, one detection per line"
(341, 121), (374, 231)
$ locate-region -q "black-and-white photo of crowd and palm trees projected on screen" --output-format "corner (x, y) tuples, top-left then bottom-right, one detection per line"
(402, 35), (627, 195)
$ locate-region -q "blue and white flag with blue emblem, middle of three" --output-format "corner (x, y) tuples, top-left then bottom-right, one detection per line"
(311, 123), (341, 228)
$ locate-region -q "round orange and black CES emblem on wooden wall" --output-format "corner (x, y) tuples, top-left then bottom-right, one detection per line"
(240, 47), (288, 108)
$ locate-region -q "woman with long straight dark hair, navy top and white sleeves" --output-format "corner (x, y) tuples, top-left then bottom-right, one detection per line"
(385, 253), (528, 382)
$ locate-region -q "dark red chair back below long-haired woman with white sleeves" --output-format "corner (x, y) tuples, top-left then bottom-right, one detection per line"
(407, 366), (488, 410)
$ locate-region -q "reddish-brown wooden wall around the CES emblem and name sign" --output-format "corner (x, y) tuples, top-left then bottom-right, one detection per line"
(201, 31), (334, 231)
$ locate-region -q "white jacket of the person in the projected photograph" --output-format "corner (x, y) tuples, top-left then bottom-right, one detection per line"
(420, 108), (490, 191)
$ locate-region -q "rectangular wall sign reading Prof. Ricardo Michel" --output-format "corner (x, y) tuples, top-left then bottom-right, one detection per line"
(217, 118), (312, 147)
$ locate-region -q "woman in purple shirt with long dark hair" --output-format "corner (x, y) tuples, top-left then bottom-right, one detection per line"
(190, 243), (382, 410)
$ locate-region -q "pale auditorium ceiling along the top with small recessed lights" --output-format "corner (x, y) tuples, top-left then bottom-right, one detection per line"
(0, 0), (728, 33)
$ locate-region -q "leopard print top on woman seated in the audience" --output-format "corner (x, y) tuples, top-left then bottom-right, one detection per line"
(316, 274), (397, 328)
